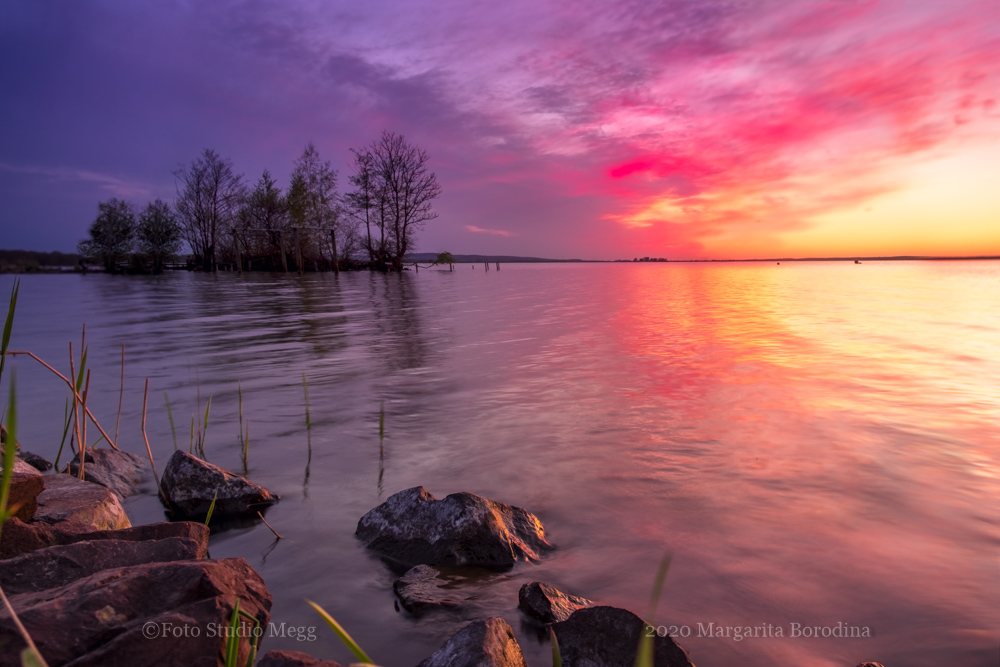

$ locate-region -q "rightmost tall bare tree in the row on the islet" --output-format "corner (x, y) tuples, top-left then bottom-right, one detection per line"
(347, 130), (441, 271)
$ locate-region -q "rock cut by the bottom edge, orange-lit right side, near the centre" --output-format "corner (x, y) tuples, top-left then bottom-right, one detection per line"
(417, 618), (528, 667)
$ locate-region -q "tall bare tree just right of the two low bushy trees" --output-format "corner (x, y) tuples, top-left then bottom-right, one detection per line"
(174, 148), (244, 271)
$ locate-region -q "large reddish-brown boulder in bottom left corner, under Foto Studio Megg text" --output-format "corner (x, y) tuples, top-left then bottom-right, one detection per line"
(0, 558), (271, 667)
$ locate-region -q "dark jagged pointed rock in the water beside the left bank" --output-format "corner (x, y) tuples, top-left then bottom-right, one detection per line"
(161, 451), (279, 519)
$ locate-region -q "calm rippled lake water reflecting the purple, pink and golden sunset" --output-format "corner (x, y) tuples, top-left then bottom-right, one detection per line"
(0, 262), (1000, 667)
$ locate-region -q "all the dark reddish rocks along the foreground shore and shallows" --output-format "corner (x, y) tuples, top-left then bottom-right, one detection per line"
(0, 449), (878, 667)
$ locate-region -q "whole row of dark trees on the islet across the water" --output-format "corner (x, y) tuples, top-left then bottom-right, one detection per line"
(77, 131), (441, 272)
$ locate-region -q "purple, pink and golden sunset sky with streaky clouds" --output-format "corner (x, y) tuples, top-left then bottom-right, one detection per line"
(0, 0), (1000, 259)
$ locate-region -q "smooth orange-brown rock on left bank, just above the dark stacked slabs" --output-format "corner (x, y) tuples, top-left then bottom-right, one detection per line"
(35, 475), (132, 532)
